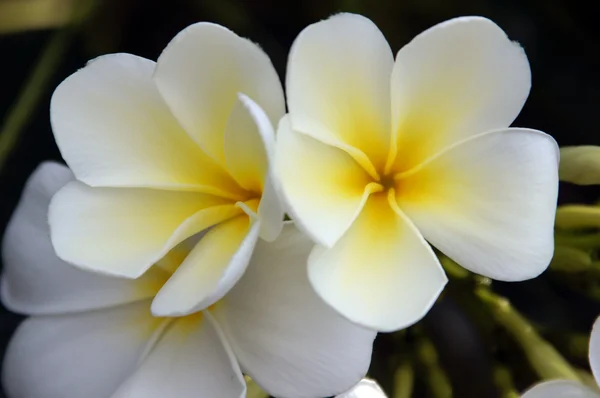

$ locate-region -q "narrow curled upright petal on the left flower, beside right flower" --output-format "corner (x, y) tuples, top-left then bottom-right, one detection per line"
(225, 94), (284, 241)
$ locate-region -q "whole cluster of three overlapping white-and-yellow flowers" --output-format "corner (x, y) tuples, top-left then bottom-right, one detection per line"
(2, 10), (559, 398)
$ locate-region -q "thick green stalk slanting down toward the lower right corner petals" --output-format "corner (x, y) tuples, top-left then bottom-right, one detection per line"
(475, 286), (582, 382)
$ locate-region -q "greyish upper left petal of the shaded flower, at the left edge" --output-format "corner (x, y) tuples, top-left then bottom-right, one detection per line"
(1, 162), (164, 315)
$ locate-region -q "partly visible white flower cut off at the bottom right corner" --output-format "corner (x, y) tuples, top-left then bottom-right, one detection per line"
(522, 318), (600, 398)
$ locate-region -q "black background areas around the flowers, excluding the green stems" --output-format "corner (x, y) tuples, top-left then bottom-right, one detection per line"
(0, 0), (600, 398)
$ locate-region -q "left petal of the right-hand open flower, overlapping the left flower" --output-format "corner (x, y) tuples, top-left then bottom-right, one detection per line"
(275, 116), (371, 246)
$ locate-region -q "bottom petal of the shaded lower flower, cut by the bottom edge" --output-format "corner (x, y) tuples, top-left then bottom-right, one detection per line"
(112, 314), (246, 398)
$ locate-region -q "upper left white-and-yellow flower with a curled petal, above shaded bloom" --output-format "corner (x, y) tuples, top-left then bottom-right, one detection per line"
(49, 23), (285, 316)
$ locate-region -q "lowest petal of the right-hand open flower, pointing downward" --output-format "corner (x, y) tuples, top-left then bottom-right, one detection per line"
(308, 193), (447, 332)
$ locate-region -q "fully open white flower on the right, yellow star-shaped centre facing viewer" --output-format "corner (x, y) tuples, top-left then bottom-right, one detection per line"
(275, 14), (558, 331)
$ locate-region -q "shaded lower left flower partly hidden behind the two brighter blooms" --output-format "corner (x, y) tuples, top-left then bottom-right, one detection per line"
(1, 163), (375, 398)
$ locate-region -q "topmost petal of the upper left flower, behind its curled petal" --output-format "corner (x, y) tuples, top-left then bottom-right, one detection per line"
(154, 22), (285, 166)
